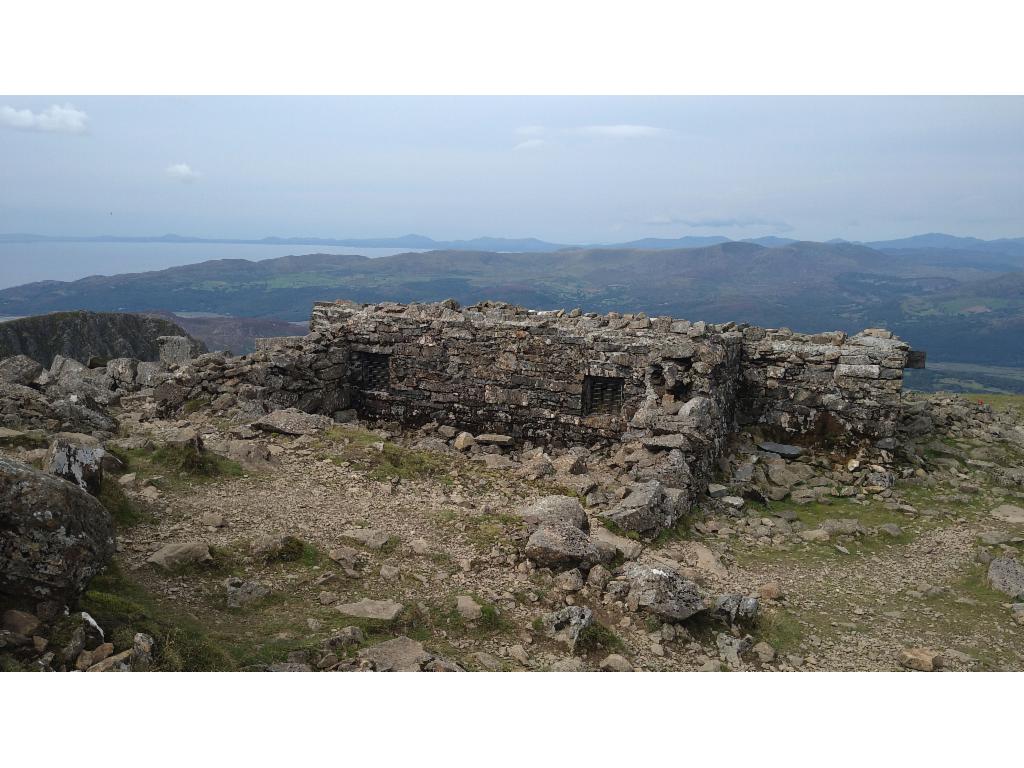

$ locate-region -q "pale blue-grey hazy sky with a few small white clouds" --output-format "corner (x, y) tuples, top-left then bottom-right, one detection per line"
(0, 96), (1024, 243)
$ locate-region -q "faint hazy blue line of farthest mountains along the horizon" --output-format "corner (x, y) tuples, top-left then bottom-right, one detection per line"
(0, 232), (1024, 256)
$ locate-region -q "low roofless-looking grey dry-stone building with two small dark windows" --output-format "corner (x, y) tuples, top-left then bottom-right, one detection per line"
(149, 300), (910, 528)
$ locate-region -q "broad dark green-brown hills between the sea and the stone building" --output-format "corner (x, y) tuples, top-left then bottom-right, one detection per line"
(0, 236), (1024, 367)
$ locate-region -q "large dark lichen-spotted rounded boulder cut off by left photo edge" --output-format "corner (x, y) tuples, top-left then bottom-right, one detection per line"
(0, 458), (114, 604)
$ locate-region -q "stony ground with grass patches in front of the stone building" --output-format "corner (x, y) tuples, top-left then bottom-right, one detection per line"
(0, 394), (1024, 671)
